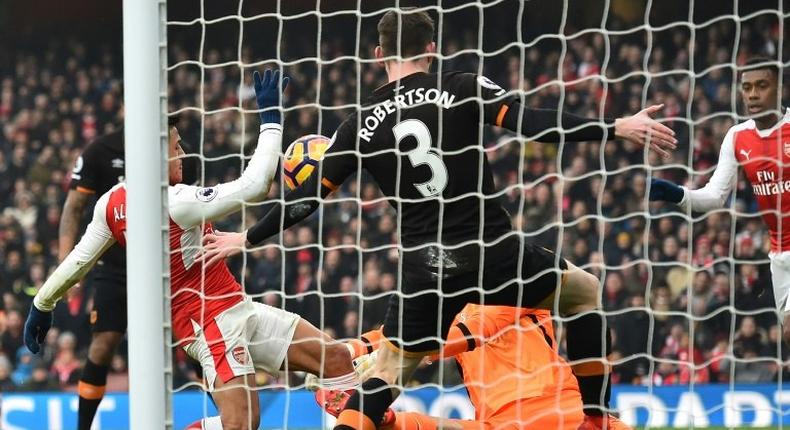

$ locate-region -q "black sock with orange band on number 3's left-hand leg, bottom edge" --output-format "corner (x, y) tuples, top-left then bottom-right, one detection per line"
(335, 378), (392, 430)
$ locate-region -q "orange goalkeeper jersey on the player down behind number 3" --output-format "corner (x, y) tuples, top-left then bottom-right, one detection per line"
(448, 304), (579, 421)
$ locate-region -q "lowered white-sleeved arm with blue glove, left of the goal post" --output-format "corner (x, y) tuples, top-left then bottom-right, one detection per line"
(24, 192), (115, 354)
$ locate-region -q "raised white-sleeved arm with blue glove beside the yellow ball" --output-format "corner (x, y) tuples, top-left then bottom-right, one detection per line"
(169, 70), (288, 227)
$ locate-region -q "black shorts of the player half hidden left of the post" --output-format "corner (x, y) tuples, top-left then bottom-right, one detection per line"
(89, 267), (126, 333)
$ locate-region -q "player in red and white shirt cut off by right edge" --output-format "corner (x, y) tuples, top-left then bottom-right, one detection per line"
(650, 58), (790, 344)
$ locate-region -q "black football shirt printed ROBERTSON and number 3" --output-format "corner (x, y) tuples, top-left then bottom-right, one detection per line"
(321, 72), (515, 246)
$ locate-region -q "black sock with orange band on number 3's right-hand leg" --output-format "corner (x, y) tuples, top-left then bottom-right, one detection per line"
(567, 313), (612, 415)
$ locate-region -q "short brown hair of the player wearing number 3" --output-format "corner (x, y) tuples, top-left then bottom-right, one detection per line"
(378, 7), (434, 58)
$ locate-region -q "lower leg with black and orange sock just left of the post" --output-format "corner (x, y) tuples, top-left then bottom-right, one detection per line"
(77, 331), (123, 430)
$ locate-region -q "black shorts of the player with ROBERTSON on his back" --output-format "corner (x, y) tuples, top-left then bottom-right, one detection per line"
(384, 236), (568, 355)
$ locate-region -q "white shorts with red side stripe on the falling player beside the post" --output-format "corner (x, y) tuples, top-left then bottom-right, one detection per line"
(184, 299), (299, 391)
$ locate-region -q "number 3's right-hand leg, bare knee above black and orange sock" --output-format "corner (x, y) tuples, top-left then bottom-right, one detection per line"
(539, 263), (624, 428)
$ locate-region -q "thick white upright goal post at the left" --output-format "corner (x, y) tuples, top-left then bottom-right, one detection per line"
(123, 0), (172, 429)
